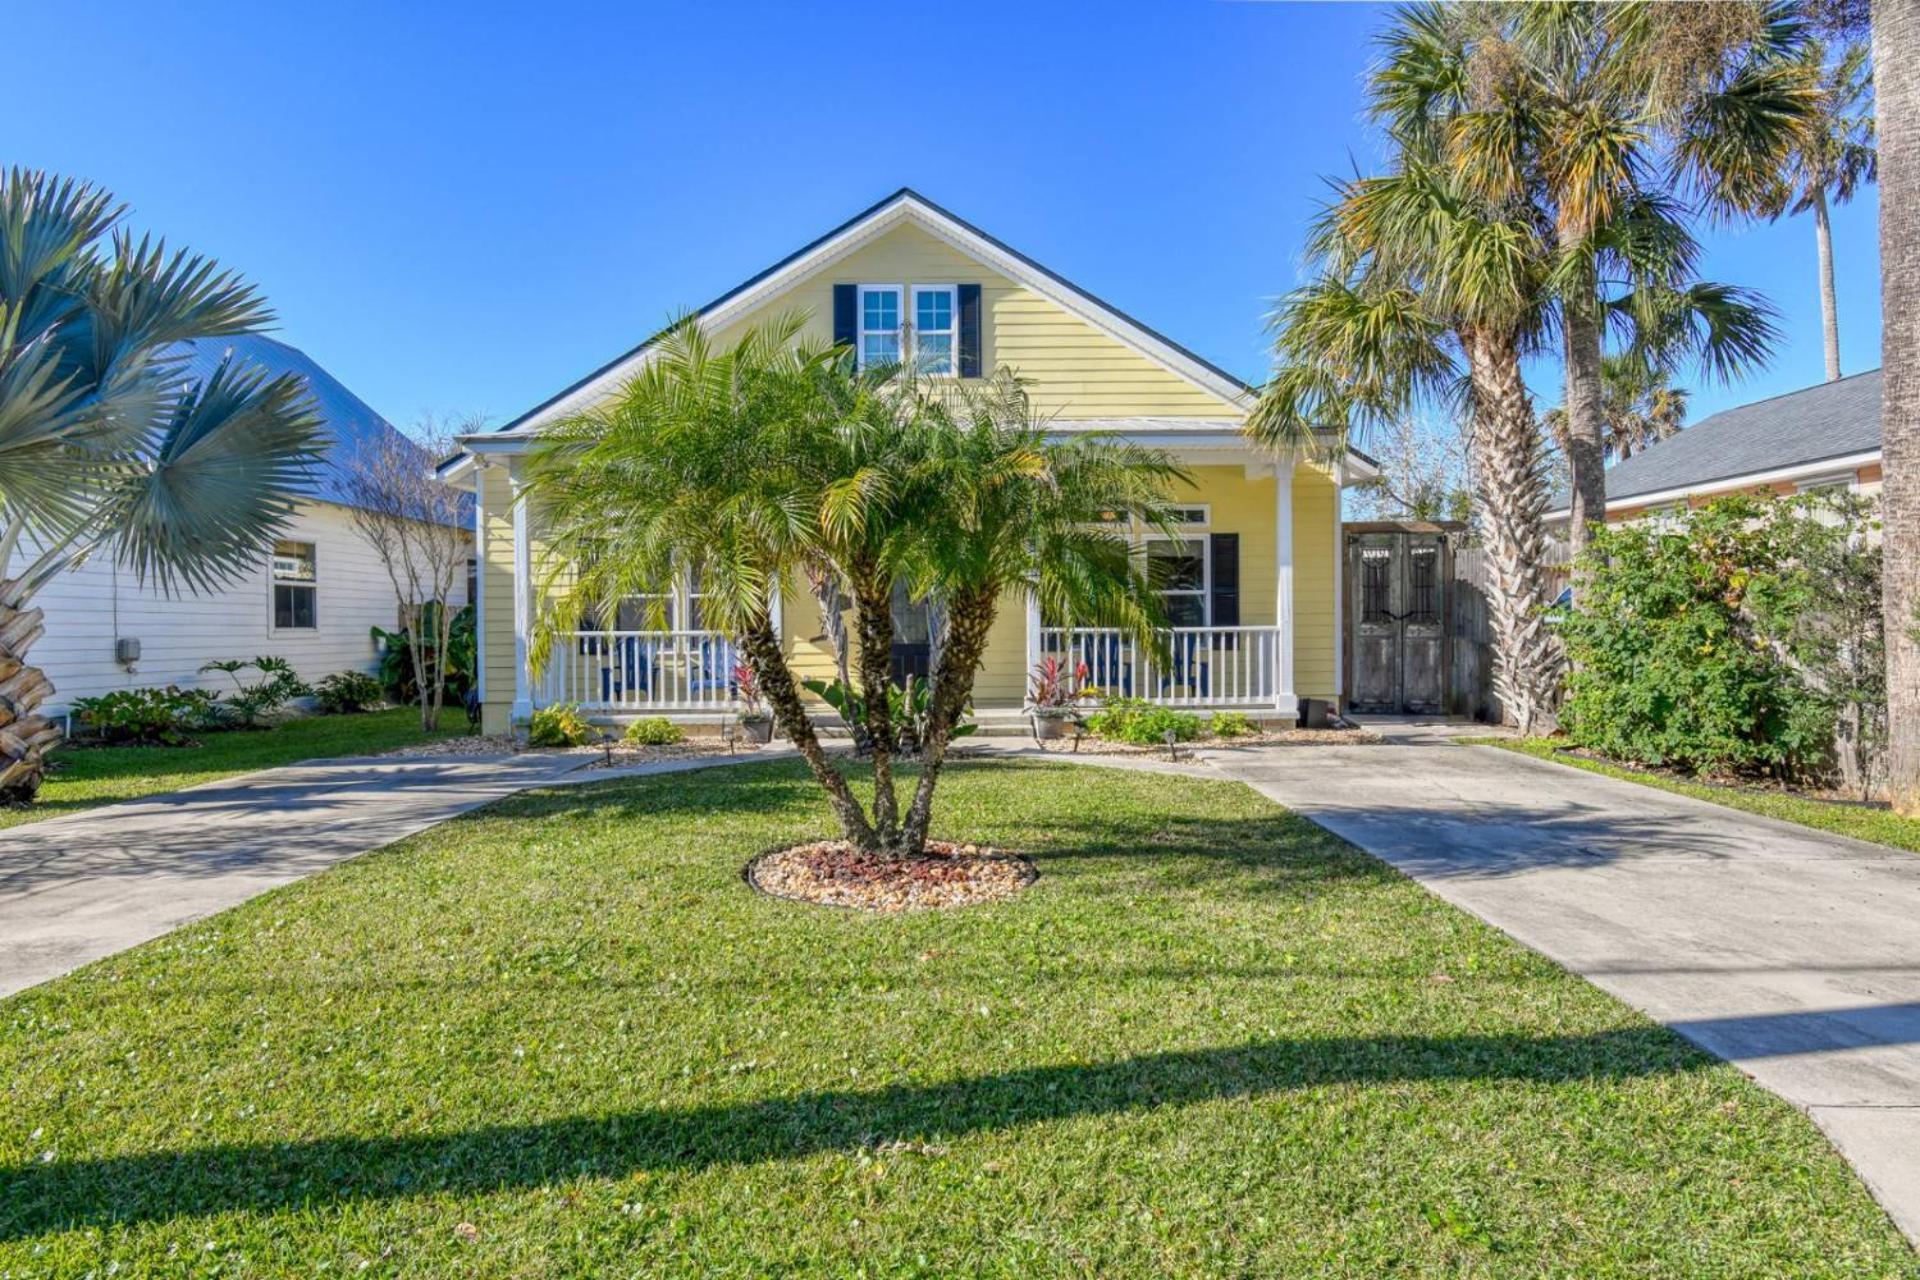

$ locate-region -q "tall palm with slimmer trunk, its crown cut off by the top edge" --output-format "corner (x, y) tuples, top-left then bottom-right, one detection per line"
(1446, 0), (1814, 557)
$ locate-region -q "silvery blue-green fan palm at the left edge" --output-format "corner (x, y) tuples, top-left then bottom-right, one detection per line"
(0, 169), (323, 802)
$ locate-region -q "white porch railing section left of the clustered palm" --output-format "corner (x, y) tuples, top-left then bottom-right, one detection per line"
(536, 631), (739, 712)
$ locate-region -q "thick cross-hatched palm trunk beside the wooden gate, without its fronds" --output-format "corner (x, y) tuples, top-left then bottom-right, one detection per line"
(1461, 330), (1559, 733)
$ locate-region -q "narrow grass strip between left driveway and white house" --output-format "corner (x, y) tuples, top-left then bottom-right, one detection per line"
(0, 706), (467, 827)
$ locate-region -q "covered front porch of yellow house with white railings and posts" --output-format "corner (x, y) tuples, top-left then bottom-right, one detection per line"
(515, 449), (1340, 723)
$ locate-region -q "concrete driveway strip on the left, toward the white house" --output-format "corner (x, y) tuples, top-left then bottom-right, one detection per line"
(0, 754), (591, 996)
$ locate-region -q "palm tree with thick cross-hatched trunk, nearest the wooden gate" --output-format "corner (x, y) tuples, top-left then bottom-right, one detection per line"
(1248, 122), (1559, 733)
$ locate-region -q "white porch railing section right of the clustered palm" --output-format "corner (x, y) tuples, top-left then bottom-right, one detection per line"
(1031, 628), (1281, 706)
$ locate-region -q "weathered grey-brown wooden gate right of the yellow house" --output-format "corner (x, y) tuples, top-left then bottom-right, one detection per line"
(1344, 524), (1453, 714)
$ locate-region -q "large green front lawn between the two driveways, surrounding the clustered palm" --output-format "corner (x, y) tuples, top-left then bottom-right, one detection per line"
(0, 762), (1916, 1278)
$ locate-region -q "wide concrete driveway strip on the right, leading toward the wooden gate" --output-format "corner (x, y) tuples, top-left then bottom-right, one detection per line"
(1210, 729), (1920, 1242)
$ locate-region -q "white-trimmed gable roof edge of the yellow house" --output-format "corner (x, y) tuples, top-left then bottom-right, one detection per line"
(487, 186), (1258, 434)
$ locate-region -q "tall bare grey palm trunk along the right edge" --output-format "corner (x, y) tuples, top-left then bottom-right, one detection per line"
(1874, 0), (1920, 814)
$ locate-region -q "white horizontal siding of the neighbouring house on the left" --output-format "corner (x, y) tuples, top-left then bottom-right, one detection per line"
(25, 503), (467, 714)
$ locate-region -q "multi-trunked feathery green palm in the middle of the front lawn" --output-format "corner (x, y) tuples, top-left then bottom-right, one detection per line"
(524, 315), (1177, 854)
